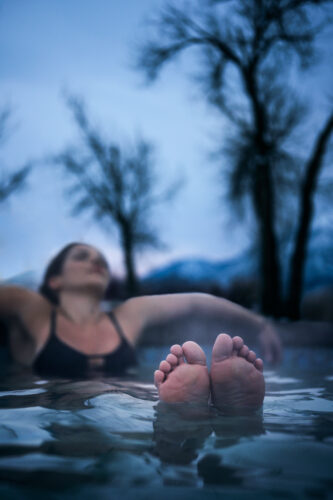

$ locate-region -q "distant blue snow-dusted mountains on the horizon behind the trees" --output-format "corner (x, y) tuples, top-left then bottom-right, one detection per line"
(5, 232), (333, 295)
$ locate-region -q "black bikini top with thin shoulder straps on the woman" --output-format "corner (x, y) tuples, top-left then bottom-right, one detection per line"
(33, 310), (137, 378)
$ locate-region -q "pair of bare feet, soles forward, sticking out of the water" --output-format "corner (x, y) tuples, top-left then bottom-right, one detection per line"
(154, 333), (265, 412)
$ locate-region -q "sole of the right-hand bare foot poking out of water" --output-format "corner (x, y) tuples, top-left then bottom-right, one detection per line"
(210, 333), (265, 414)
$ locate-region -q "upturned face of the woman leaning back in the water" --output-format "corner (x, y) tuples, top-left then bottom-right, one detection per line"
(50, 245), (110, 295)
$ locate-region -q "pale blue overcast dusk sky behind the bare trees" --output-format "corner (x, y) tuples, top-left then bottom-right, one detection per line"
(0, 0), (333, 279)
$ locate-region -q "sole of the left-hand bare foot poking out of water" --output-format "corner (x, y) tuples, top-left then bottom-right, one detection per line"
(154, 341), (210, 405)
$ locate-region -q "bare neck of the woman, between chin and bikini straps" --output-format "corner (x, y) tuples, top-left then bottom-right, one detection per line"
(59, 292), (103, 325)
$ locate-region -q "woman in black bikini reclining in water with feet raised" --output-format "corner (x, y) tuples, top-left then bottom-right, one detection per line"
(0, 243), (281, 410)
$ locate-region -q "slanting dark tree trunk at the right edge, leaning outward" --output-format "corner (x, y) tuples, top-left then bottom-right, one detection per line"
(286, 113), (333, 320)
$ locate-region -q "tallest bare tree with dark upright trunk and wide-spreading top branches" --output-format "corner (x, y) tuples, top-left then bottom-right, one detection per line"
(138, 0), (332, 316)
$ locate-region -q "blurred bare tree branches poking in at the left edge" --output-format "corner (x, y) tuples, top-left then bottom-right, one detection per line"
(0, 107), (31, 203)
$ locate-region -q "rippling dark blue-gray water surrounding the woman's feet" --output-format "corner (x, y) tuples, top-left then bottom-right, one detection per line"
(0, 348), (333, 500)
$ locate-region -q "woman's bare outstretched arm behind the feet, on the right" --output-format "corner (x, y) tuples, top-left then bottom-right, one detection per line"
(117, 293), (281, 362)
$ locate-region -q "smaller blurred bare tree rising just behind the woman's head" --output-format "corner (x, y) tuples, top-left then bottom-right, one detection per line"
(56, 97), (180, 295)
